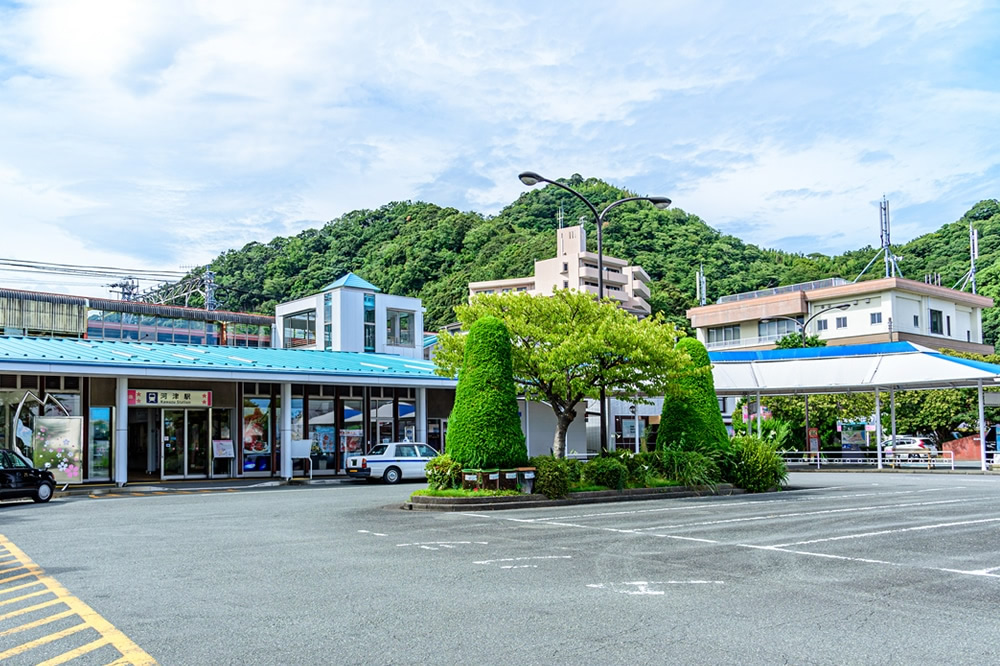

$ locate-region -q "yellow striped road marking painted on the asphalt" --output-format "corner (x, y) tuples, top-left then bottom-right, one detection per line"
(0, 535), (156, 665)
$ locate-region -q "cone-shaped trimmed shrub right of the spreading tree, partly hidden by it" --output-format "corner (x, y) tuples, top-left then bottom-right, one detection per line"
(656, 338), (729, 450)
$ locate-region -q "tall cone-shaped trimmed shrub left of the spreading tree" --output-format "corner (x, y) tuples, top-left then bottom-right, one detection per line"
(447, 316), (528, 468)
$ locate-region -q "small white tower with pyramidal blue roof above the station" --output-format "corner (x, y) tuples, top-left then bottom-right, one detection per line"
(274, 273), (424, 359)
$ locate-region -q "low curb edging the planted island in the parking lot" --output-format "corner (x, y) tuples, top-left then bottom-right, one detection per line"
(400, 484), (745, 511)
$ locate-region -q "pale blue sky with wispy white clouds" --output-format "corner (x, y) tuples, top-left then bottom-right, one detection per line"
(0, 0), (1000, 296)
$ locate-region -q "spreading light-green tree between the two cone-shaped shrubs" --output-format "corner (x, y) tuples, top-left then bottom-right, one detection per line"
(434, 290), (688, 457)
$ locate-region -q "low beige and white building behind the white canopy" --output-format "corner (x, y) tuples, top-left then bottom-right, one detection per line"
(687, 277), (993, 354)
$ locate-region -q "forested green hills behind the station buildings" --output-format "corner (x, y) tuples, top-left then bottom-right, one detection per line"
(195, 175), (1000, 342)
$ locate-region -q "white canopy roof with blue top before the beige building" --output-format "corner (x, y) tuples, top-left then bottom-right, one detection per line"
(708, 342), (1000, 395)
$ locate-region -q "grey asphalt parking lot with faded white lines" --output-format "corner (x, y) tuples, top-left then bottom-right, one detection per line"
(0, 473), (1000, 664)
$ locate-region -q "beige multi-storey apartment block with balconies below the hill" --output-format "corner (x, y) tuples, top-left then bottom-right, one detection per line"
(469, 225), (650, 317)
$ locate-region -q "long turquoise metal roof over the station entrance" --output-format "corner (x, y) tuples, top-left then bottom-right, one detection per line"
(0, 336), (454, 386)
